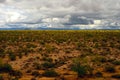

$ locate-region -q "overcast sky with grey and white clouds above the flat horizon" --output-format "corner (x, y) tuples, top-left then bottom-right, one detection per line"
(0, 0), (120, 29)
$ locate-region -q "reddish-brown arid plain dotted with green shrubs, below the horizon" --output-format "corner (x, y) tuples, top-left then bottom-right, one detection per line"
(0, 30), (120, 80)
